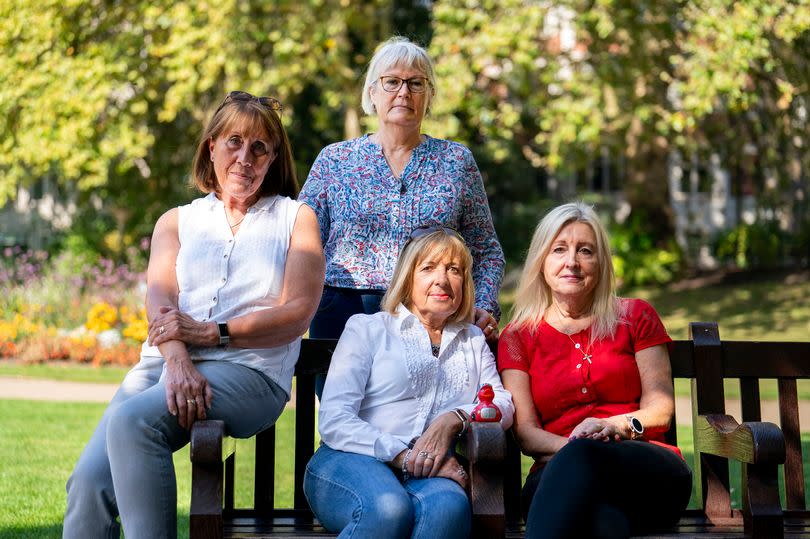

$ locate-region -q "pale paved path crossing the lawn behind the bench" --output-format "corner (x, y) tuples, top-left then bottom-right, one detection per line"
(0, 376), (810, 428)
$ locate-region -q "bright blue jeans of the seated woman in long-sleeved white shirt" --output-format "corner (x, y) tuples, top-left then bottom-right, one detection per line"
(304, 444), (472, 539)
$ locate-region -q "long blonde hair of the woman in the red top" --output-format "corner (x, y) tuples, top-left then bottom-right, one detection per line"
(512, 202), (622, 341)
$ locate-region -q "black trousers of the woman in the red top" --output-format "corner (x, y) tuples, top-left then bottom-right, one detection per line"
(522, 439), (692, 539)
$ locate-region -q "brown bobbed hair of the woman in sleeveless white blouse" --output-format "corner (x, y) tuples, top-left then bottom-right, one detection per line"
(191, 97), (299, 198)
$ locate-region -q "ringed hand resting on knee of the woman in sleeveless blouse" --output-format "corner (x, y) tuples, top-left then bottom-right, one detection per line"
(164, 357), (213, 429)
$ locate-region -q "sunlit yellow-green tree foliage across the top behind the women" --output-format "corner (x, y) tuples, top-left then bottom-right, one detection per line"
(0, 0), (810, 265)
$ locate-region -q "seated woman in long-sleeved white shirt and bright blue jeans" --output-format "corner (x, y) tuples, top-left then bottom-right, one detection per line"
(304, 227), (513, 538)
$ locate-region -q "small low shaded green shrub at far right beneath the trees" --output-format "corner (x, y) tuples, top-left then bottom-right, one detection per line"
(715, 221), (791, 270)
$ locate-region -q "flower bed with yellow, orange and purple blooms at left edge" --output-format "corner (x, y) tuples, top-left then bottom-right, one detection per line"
(0, 245), (147, 365)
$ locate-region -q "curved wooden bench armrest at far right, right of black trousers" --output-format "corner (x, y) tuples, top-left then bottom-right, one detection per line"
(695, 414), (785, 464)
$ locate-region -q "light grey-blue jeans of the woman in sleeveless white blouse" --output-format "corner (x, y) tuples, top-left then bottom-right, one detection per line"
(63, 358), (287, 539)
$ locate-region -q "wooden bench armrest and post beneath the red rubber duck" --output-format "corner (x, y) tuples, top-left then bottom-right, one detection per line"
(457, 421), (506, 538)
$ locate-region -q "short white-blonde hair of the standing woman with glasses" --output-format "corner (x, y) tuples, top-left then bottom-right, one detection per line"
(361, 36), (436, 116)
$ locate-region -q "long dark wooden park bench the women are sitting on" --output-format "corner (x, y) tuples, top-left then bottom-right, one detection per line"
(190, 323), (810, 538)
